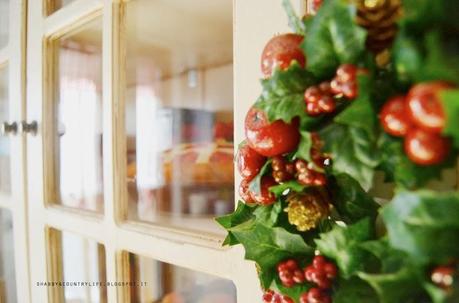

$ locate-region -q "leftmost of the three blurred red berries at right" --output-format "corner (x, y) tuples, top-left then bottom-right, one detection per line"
(379, 96), (411, 137)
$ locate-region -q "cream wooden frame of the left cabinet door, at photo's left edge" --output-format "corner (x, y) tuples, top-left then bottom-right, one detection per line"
(0, 0), (30, 302)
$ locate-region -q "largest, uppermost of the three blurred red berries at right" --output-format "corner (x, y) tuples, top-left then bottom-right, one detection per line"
(407, 81), (451, 133)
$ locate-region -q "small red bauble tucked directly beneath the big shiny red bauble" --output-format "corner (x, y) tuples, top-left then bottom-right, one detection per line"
(237, 144), (266, 180)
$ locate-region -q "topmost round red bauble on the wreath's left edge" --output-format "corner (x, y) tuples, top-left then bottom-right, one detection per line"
(261, 34), (306, 77)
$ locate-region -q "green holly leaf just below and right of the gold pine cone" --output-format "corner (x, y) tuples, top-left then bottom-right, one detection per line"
(315, 219), (373, 278)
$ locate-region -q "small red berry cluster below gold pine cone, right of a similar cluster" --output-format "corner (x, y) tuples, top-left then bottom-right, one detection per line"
(304, 256), (338, 289)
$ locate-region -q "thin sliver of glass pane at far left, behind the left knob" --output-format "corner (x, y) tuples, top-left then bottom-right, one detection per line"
(0, 66), (11, 193)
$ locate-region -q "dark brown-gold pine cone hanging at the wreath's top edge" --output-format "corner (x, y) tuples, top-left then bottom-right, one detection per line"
(355, 0), (402, 63)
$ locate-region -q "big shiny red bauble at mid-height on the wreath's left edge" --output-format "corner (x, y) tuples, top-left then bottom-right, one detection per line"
(245, 107), (300, 157)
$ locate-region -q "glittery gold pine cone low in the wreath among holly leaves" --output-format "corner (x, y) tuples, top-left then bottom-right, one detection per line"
(285, 192), (330, 231)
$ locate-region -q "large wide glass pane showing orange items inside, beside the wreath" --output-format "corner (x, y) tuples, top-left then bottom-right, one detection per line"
(124, 0), (234, 232)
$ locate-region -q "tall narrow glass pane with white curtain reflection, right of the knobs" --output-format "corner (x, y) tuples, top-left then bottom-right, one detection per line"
(53, 18), (103, 212)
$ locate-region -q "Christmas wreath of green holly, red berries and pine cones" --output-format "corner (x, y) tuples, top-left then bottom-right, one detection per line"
(217, 0), (459, 303)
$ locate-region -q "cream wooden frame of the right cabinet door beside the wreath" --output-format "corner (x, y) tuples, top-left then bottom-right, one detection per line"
(24, 0), (304, 303)
